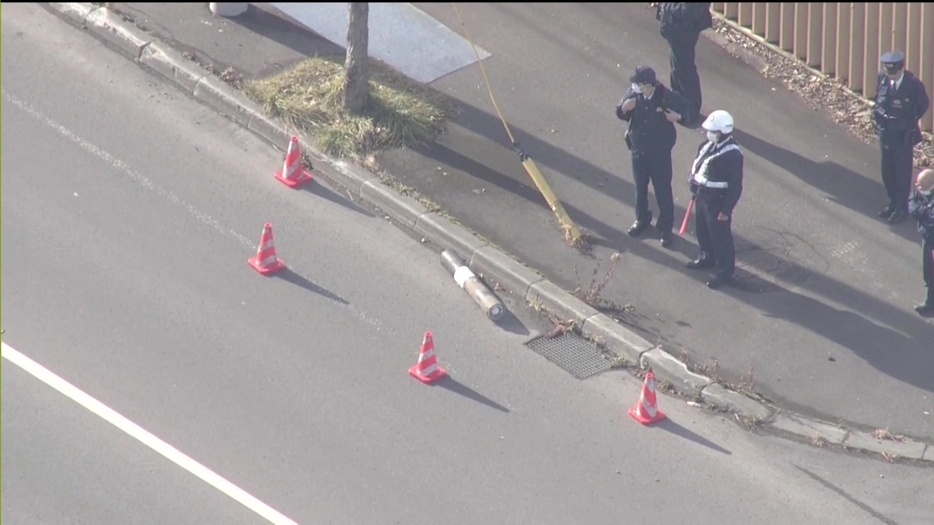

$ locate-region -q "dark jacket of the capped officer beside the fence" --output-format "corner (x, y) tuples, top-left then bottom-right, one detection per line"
(872, 71), (931, 146)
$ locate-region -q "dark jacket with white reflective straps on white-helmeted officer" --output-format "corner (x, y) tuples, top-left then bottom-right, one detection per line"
(690, 136), (743, 217)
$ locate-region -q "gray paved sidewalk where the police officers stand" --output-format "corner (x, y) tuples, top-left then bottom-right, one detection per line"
(97, 3), (934, 439)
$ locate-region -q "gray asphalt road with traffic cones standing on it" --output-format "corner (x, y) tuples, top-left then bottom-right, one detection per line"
(2, 4), (934, 524)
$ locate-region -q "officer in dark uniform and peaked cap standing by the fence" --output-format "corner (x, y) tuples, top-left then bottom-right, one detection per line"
(872, 51), (930, 223)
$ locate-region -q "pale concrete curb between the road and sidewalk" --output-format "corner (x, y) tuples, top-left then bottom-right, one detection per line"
(49, 3), (934, 462)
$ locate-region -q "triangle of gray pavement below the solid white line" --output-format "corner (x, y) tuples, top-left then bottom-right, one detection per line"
(2, 362), (262, 525)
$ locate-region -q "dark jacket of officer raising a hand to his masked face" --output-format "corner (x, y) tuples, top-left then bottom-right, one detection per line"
(616, 83), (697, 155)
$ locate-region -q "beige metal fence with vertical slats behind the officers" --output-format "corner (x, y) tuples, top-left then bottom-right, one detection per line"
(712, 2), (934, 131)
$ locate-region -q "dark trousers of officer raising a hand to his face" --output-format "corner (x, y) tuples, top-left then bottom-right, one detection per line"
(632, 151), (675, 232)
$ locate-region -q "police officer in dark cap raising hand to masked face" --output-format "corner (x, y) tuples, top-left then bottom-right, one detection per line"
(616, 66), (696, 248)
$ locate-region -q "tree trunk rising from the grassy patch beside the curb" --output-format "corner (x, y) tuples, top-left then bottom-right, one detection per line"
(344, 2), (370, 114)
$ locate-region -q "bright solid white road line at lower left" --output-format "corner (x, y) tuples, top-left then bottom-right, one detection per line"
(0, 343), (297, 525)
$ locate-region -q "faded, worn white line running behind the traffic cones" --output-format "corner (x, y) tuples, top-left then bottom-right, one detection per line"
(2, 90), (382, 330)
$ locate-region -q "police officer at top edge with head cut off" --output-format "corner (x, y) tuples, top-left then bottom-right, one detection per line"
(655, 2), (713, 111)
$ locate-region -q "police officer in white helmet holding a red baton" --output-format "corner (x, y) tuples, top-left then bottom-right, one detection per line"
(687, 109), (743, 289)
